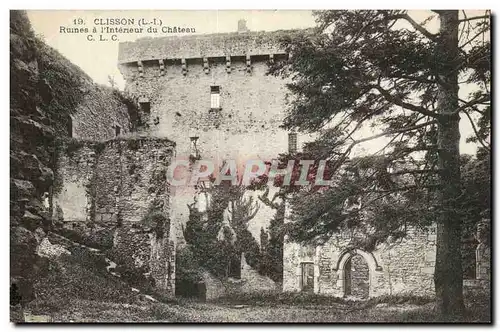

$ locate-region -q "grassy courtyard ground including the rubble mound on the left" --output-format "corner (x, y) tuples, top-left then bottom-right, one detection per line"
(11, 238), (491, 323)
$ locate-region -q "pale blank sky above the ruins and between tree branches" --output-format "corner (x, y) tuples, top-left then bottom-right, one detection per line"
(24, 10), (484, 154)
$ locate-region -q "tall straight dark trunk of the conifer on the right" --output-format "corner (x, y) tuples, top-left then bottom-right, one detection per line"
(434, 10), (464, 318)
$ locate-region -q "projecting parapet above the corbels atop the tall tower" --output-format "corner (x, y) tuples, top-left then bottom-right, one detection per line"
(118, 30), (304, 64)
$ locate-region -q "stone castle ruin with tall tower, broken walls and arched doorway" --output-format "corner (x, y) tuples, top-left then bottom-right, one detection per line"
(13, 11), (490, 298)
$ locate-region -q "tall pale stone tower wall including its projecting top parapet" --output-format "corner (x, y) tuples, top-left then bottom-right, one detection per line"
(119, 33), (300, 241)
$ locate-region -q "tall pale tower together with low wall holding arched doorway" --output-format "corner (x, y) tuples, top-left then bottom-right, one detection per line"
(115, 22), (444, 297)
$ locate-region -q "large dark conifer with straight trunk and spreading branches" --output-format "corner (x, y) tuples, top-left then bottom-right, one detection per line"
(270, 10), (491, 316)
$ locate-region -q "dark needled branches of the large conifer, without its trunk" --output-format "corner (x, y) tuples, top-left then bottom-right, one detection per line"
(270, 10), (491, 247)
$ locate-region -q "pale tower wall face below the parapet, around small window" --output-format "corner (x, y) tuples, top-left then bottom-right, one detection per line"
(120, 51), (294, 241)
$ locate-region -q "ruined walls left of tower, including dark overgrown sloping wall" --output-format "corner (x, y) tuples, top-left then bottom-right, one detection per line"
(9, 11), (180, 305)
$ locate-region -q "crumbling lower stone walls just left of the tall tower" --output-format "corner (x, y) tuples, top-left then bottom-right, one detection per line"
(48, 61), (176, 294)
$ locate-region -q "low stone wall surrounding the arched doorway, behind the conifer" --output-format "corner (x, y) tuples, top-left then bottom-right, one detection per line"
(283, 229), (436, 297)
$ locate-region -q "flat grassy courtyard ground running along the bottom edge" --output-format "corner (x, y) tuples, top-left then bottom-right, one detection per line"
(13, 296), (490, 323)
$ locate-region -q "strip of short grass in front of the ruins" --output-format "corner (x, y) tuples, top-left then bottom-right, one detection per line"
(18, 299), (488, 323)
